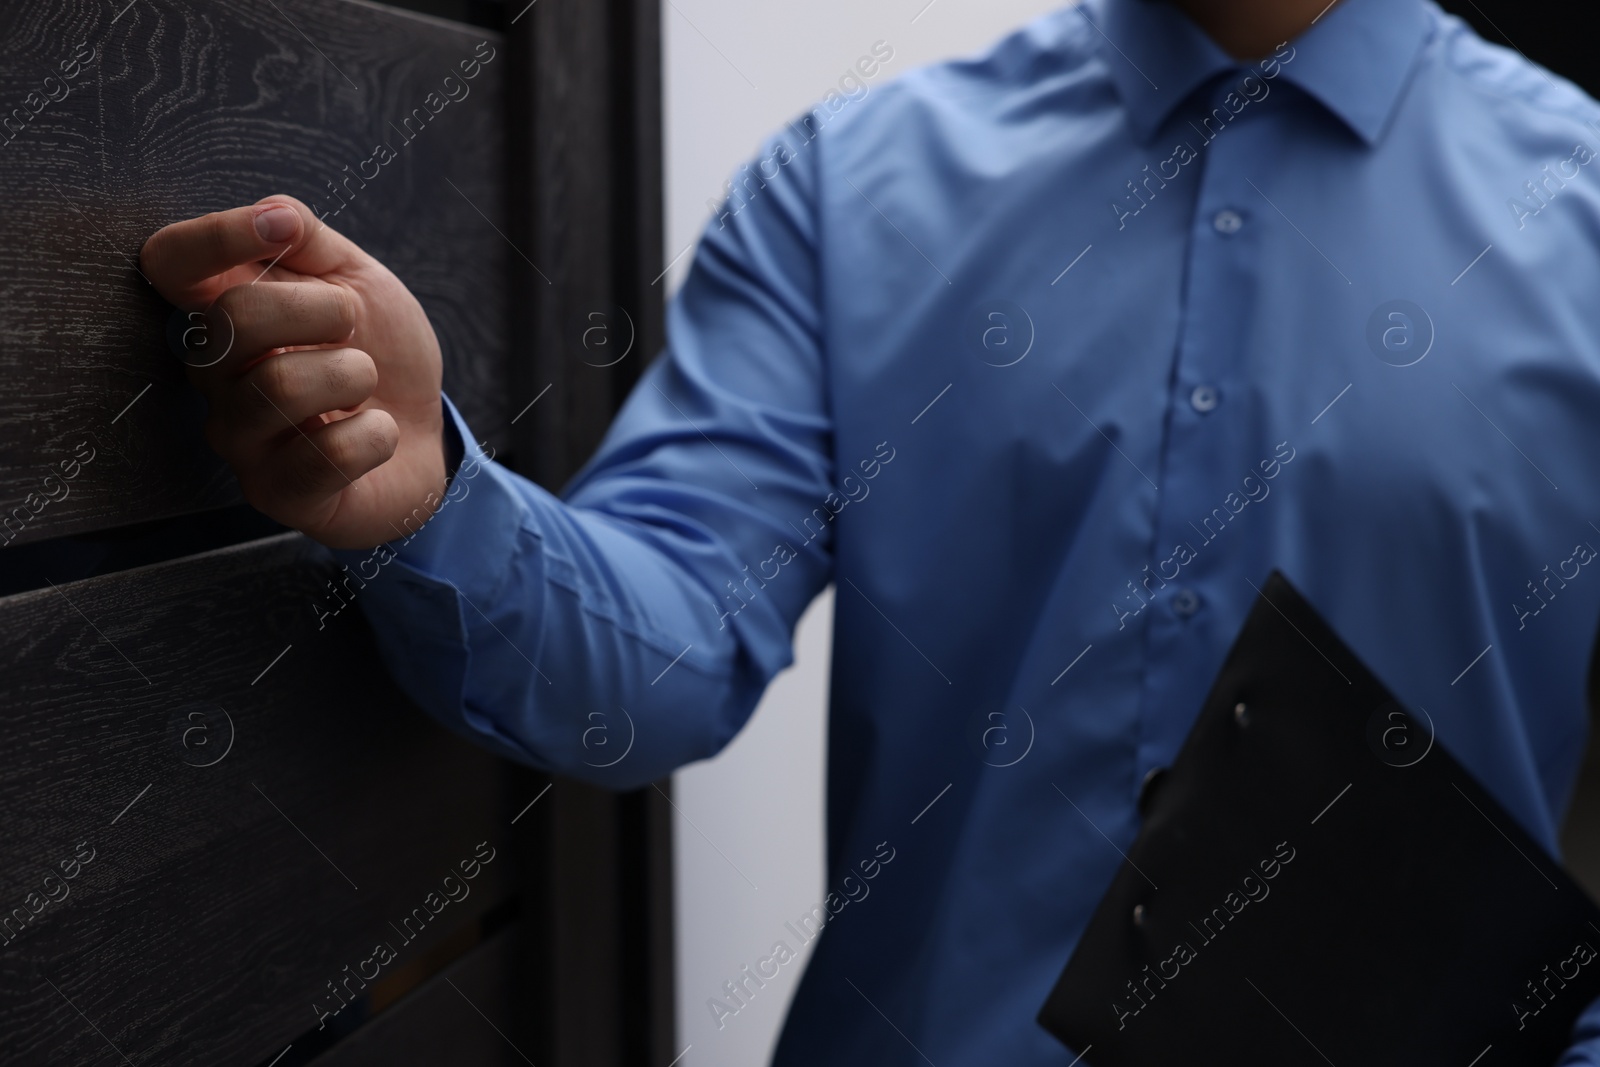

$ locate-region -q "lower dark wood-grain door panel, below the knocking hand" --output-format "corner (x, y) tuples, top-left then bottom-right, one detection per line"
(0, 534), (512, 1065)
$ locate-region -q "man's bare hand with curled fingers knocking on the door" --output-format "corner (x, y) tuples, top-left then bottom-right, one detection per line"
(139, 197), (445, 549)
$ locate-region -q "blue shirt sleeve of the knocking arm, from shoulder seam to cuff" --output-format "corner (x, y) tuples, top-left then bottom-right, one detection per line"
(336, 123), (840, 787)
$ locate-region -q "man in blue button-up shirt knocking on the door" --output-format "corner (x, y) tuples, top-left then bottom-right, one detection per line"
(144, 0), (1600, 1067)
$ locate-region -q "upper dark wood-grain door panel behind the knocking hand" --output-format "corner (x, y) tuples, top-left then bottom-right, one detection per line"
(0, 0), (515, 542)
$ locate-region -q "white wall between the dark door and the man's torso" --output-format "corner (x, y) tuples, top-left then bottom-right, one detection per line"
(661, 0), (1058, 1067)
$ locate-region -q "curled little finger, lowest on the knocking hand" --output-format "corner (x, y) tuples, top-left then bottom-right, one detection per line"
(249, 408), (400, 528)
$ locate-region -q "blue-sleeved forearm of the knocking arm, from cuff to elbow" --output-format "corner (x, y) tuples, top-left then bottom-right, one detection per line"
(338, 396), (816, 787)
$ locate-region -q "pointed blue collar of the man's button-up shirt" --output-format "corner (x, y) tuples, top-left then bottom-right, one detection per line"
(1080, 0), (1432, 144)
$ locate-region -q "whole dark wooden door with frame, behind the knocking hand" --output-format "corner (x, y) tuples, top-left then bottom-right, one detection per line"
(0, 0), (677, 1067)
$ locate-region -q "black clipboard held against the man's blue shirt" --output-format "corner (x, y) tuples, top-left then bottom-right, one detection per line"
(1038, 571), (1600, 1067)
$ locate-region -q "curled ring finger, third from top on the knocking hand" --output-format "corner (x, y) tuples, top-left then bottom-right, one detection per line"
(206, 349), (378, 467)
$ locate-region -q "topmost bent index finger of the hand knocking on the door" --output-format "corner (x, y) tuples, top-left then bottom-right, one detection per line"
(139, 197), (355, 309)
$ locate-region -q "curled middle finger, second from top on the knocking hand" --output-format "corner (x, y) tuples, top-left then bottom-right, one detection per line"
(182, 282), (357, 388)
